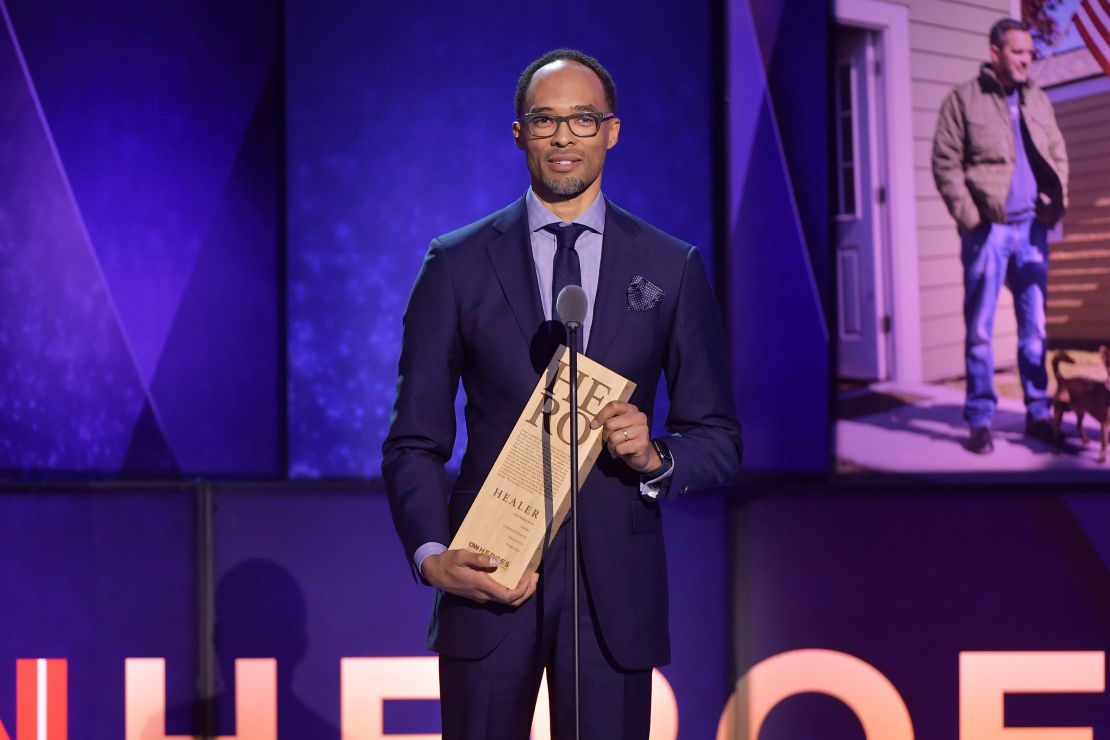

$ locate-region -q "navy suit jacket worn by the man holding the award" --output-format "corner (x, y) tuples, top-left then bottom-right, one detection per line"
(382, 199), (740, 670)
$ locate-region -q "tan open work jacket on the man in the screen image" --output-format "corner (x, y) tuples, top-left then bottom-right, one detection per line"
(932, 64), (1068, 231)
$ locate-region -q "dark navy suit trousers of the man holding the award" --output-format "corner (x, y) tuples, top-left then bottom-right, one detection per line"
(440, 520), (652, 740)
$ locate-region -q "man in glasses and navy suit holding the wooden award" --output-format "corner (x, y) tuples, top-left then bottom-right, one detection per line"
(382, 49), (740, 740)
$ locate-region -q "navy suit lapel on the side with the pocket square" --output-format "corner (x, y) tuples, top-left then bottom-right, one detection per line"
(586, 200), (639, 364)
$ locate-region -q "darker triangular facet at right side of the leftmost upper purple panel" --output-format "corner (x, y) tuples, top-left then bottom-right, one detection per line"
(151, 62), (285, 476)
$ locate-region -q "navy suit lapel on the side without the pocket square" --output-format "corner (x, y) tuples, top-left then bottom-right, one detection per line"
(486, 197), (544, 345)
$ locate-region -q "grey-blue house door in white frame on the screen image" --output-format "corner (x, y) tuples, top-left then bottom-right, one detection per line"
(833, 26), (889, 381)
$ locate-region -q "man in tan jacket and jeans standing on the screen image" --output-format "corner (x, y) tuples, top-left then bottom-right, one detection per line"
(932, 18), (1068, 455)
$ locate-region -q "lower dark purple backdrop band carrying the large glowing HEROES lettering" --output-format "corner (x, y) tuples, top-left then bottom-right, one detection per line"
(0, 484), (1110, 740)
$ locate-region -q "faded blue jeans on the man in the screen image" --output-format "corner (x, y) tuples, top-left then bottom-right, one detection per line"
(960, 219), (1049, 427)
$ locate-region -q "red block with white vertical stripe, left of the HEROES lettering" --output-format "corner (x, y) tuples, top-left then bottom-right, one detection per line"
(0, 658), (68, 740)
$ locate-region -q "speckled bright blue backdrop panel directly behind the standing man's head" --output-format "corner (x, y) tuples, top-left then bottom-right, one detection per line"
(286, 2), (717, 477)
